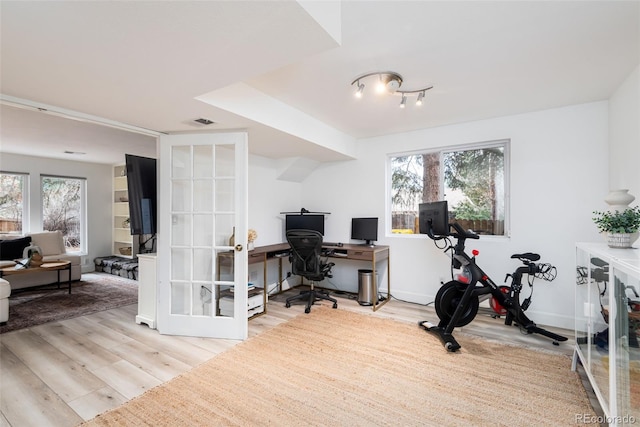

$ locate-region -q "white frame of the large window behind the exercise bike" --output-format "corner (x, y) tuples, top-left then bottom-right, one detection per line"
(385, 138), (511, 239)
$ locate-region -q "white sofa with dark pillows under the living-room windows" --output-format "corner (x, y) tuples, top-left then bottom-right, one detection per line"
(0, 231), (82, 289)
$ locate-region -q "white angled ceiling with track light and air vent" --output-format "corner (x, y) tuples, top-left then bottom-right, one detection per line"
(0, 0), (640, 164)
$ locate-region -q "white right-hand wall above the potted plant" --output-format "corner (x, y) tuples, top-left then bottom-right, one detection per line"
(609, 65), (640, 198)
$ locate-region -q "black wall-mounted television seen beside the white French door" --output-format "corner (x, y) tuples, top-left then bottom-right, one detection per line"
(125, 154), (158, 235)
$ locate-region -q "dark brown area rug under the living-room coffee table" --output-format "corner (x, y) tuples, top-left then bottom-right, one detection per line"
(0, 273), (138, 334)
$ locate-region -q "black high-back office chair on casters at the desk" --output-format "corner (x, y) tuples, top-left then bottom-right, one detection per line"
(285, 230), (338, 313)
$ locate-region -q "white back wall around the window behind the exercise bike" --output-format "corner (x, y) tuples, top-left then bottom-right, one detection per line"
(302, 102), (609, 328)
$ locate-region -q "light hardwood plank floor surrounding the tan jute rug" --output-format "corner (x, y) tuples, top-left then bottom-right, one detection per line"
(0, 280), (599, 427)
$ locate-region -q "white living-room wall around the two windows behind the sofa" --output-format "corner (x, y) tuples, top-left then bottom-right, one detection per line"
(0, 153), (112, 272)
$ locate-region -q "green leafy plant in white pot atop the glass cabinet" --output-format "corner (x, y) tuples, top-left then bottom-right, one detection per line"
(593, 206), (640, 248)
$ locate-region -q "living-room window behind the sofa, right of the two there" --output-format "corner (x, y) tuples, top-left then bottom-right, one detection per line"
(41, 176), (86, 252)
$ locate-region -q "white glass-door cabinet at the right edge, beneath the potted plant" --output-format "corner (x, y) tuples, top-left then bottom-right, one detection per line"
(573, 243), (640, 425)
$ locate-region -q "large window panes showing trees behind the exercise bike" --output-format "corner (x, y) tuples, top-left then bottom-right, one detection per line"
(388, 141), (509, 236)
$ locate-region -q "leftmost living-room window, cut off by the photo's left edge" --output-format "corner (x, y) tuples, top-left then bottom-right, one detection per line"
(0, 172), (29, 233)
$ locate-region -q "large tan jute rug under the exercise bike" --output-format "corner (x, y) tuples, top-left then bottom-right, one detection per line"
(83, 307), (595, 427)
